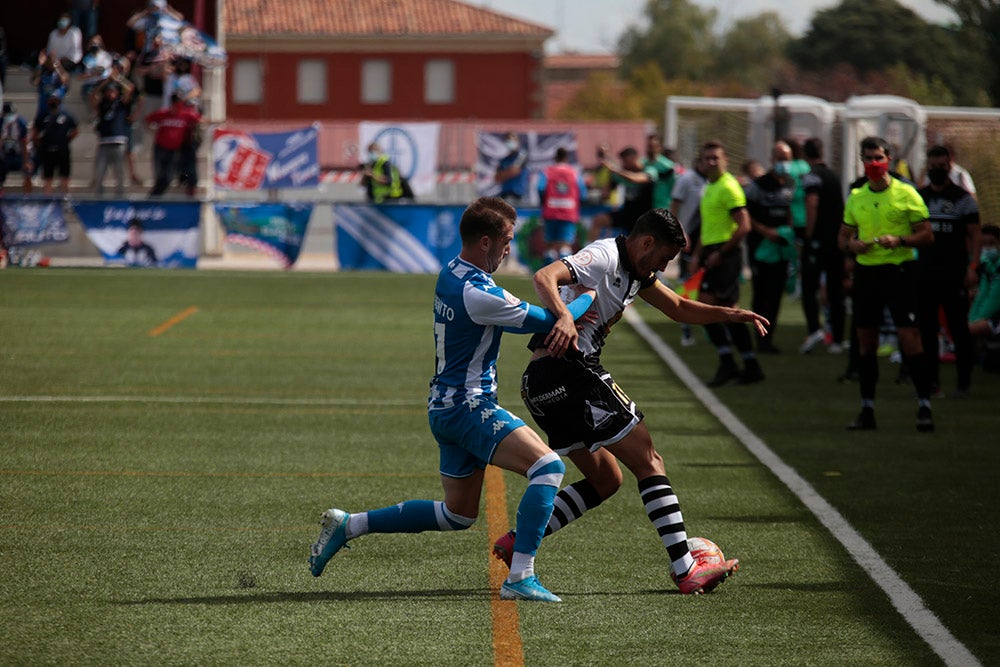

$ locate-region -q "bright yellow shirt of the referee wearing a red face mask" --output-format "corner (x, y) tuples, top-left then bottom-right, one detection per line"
(844, 178), (930, 266)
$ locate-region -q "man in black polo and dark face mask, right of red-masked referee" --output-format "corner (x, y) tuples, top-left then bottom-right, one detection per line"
(917, 146), (982, 396)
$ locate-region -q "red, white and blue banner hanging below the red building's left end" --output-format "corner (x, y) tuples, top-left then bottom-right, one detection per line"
(212, 125), (319, 190)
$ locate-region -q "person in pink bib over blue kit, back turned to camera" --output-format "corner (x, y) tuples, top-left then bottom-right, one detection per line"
(538, 146), (587, 264)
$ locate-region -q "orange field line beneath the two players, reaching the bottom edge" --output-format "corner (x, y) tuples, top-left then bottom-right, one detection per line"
(486, 466), (524, 667)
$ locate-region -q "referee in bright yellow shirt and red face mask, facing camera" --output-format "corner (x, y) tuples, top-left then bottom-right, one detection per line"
(838, 137), (934, 432)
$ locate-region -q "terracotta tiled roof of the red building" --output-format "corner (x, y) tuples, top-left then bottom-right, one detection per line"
(223, 0), (554, 39)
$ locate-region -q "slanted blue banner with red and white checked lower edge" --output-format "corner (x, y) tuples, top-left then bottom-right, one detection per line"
(215, 203), (313, 269)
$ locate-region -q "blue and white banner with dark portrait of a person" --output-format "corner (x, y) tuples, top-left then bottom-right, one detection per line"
(73, 201), (201, 269)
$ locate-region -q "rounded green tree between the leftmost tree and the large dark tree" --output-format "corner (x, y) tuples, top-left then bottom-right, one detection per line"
(713, 12), (792, 91)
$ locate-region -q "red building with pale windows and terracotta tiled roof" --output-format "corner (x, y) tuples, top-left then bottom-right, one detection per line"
(220, 0), (553, 122)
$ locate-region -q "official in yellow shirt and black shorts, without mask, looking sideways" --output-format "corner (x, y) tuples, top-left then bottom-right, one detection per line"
(691, 141), (764, 387)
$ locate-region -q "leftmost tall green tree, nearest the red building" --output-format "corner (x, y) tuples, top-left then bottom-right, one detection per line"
(618, 0), (718, 80)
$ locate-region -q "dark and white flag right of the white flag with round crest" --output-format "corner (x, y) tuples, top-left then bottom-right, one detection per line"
(476, 131), (577, 204)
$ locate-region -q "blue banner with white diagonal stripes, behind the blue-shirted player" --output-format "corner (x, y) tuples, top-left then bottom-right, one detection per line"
(333, 204), (465, 273)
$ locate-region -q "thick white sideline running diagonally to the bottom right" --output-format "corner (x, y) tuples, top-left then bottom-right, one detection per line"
(625, 308), (982, 666)
